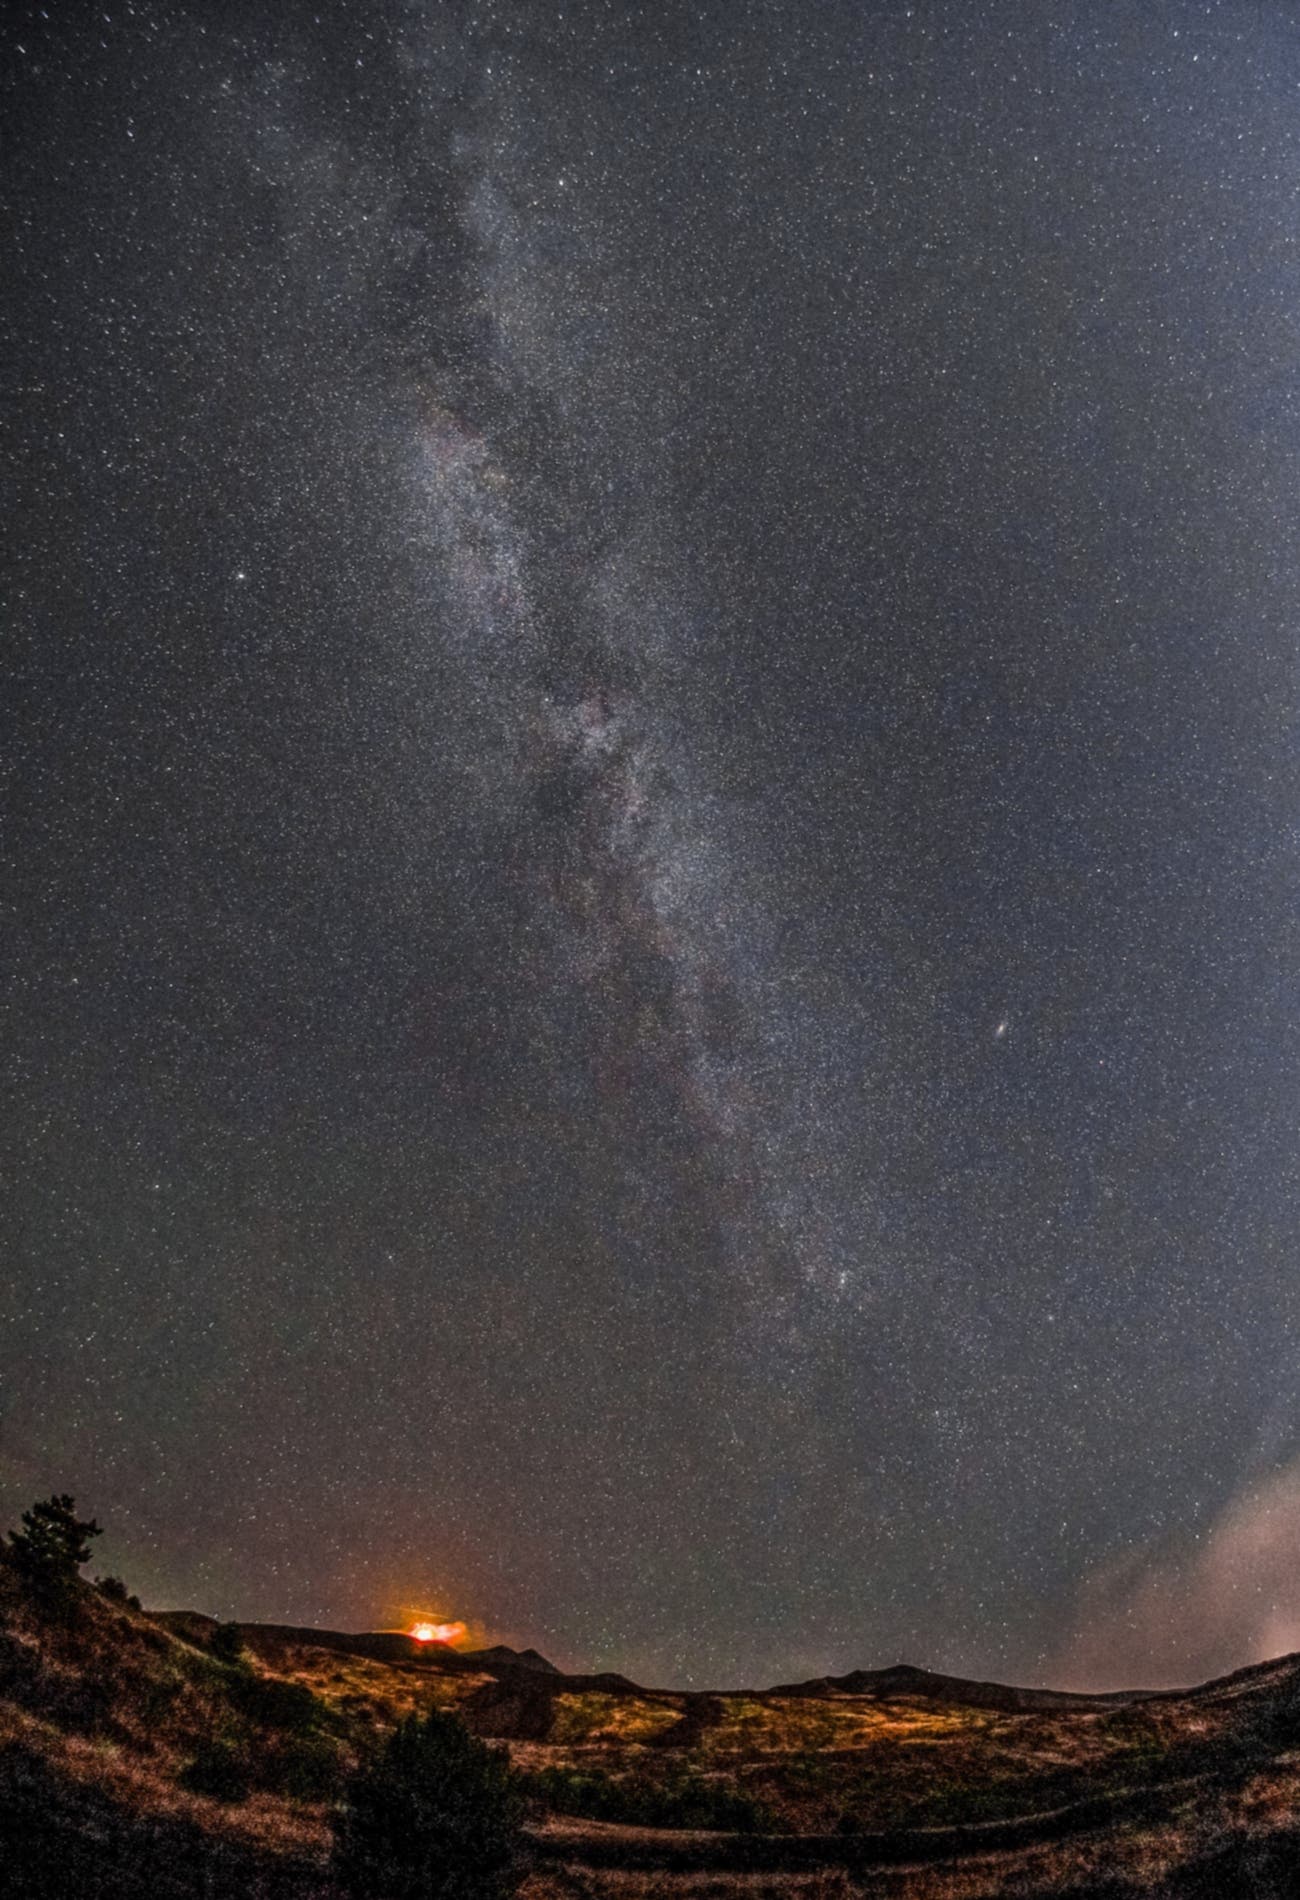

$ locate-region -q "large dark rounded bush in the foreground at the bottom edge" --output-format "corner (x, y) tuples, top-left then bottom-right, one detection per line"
(335, 1710), (523, 1900)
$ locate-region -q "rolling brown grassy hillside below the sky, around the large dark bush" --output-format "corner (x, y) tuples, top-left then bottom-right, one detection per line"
(0, 1564), (1300, 1900)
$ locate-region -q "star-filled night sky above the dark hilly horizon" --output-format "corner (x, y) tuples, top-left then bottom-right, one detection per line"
(0, 0), (1300, 1687)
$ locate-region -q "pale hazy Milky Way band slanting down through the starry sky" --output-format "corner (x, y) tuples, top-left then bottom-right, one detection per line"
(401, 81), (878, 1351)
